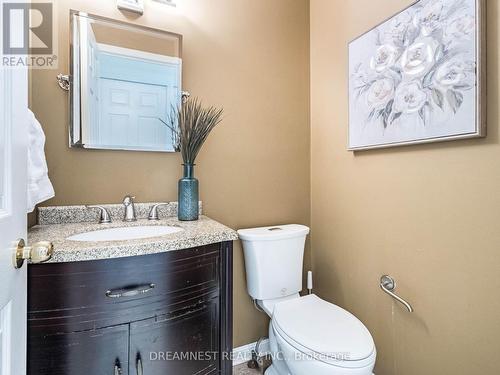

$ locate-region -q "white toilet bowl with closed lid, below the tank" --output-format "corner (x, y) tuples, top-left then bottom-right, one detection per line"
(266, 295), (376, 375)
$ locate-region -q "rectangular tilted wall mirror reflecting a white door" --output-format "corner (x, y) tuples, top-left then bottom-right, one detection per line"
(70, 11), (182, 152)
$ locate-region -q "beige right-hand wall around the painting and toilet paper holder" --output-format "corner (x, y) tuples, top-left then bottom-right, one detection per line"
(310, 0), (500, 375)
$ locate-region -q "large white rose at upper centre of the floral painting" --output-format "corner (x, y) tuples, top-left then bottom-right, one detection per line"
(401, 38), (439, 78)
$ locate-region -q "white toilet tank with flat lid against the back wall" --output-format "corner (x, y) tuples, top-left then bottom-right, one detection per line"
(238, 224), (309, 300)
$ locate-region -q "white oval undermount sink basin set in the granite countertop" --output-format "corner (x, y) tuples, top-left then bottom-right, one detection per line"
(67, 225), (184, 241)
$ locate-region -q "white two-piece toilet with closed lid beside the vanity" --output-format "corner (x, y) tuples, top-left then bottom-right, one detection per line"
(238, 224), (376, 375)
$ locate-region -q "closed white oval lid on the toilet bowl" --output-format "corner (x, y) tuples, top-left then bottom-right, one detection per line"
(272, 294), (375, 361)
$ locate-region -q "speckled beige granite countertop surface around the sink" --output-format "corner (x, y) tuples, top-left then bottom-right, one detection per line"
(28, 206), (238, 263)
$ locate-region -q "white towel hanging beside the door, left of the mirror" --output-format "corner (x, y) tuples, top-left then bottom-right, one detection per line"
(28, 110), (55, 212)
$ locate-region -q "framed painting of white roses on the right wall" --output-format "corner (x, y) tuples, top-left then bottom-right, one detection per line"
(349, 0), (486, 150)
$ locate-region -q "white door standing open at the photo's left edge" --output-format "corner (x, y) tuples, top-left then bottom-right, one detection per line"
(0, 6), (28, 375)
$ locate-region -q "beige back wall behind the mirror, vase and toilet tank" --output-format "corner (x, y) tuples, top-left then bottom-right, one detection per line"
(31, 0), (310, 345)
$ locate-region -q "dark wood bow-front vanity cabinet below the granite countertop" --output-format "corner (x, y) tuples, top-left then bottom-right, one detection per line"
(28, 242), (232, 375)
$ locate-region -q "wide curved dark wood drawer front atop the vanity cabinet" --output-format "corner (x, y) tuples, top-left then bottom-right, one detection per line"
(28, 244), (221, 329)
